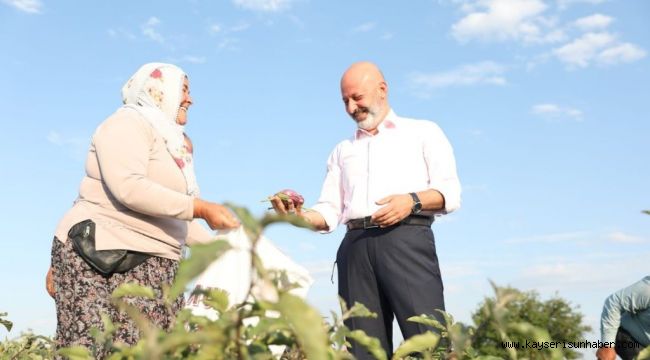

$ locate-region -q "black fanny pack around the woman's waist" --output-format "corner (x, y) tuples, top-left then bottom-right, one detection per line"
(68, 220), (151, 276)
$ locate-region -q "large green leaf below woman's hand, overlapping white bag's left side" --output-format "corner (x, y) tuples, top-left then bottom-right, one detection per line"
(167, 240), (231, 303)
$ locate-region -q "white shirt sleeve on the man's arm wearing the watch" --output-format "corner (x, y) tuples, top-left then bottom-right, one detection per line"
(424, 123), (461, 214)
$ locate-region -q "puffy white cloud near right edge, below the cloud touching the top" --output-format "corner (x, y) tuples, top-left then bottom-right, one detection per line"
(553, 32), (646, 68)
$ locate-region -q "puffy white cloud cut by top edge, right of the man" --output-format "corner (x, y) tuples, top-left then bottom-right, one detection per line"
(452, 0), (565, 43)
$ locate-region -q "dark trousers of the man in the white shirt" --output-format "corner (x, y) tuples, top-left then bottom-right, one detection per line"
(336, 225), (445, 359)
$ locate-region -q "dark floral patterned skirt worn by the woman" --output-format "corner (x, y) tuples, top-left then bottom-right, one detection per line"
(52, 237), (184, 358)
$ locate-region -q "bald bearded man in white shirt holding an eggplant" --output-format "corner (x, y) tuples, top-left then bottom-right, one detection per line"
(272, 62), (461, 359)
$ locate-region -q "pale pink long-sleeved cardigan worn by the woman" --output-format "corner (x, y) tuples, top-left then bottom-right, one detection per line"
(55, 109), (212, 259)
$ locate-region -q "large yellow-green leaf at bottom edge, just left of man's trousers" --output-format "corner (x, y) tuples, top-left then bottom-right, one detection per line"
(277, 293), (329, 360)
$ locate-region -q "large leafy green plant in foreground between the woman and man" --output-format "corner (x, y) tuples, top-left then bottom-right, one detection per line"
(59, 204), (386, 360)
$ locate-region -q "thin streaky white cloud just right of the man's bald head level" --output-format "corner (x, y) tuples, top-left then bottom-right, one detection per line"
(410, 61), (507, 90)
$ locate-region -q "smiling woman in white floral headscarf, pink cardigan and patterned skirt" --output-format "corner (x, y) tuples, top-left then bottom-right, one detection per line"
(48, 63), (239, 358)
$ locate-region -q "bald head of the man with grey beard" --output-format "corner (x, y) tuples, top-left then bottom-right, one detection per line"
(341, 61), (390, 134)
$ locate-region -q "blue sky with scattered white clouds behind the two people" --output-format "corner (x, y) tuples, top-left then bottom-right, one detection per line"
(0, 0), (650, 352)
